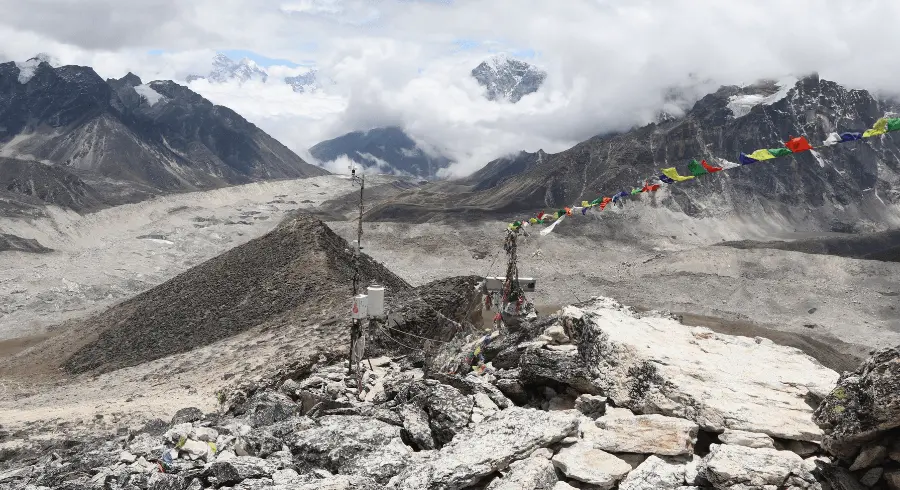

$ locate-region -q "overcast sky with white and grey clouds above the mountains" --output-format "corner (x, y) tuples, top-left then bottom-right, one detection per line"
(0, 0), (900, 174)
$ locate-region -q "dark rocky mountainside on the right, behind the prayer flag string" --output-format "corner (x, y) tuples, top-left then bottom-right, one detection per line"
(369, 76), (900, 235)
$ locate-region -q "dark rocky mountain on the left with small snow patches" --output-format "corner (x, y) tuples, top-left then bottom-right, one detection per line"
(0, 62), (327, 203)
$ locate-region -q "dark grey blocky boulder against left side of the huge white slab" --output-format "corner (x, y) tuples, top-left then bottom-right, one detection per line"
(507, 348), (600, 396)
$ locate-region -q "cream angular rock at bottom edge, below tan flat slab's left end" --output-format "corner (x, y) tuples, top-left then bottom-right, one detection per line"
(553, 442), (632, 490)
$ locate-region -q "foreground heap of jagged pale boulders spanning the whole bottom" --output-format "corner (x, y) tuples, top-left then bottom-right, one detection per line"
(0, 283), (900, 490)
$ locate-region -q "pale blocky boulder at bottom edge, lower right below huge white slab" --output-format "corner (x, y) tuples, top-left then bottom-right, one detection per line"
(698, 444), (817, 490)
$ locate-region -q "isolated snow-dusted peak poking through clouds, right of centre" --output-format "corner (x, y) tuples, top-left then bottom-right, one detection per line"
(472, 54), (547, 103)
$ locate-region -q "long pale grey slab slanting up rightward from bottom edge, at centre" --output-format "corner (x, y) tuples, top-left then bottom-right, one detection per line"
(393, 407), (578, 490)
